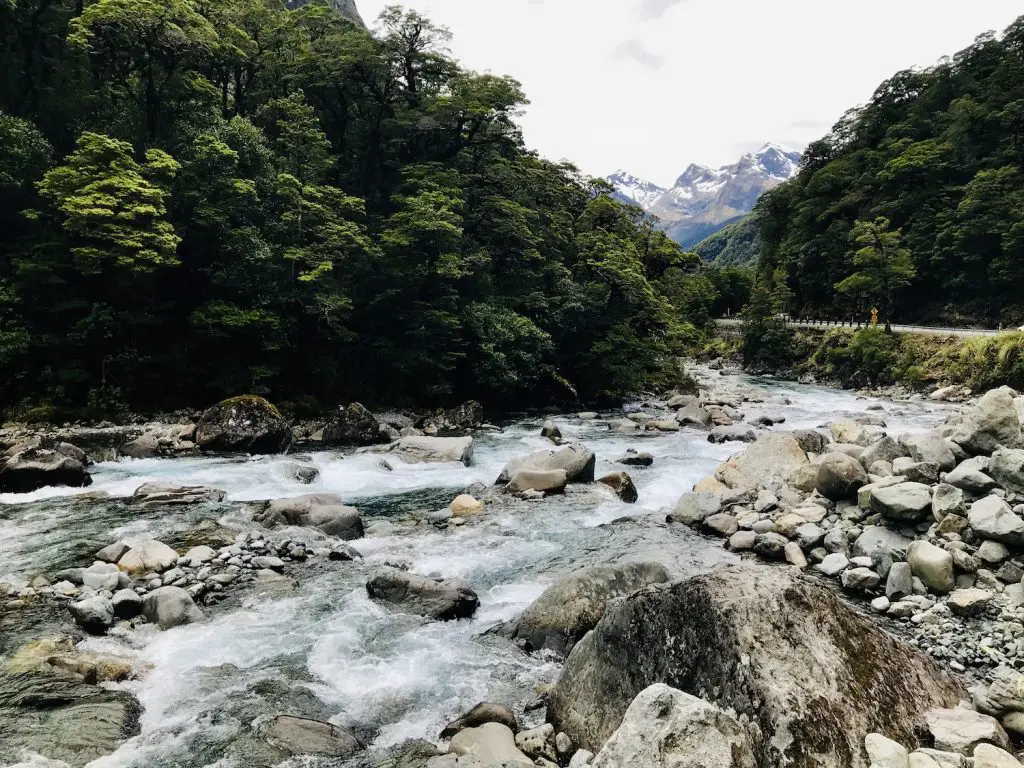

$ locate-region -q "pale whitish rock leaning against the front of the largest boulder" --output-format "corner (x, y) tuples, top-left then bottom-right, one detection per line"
(592, 683), (757, 768)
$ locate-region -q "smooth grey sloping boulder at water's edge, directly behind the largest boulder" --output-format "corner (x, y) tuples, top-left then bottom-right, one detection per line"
(495, 562), (669, 654)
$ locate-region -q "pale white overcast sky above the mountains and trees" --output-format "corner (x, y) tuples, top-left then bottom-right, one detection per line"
(356, 0), (1024, 185)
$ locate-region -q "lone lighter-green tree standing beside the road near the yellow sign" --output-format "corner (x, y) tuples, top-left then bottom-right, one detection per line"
(836, 216), (916, 330)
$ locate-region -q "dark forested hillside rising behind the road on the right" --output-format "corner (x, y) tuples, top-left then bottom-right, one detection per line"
(755, 17), (1024, 326)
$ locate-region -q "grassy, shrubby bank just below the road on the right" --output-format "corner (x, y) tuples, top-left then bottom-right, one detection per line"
(701, 328), (1024, 391)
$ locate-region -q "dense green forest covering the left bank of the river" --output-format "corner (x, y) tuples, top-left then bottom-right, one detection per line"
(0, 0), (749, 416)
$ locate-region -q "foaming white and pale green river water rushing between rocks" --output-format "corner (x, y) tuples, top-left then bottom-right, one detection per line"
(0, 382), (942, 768)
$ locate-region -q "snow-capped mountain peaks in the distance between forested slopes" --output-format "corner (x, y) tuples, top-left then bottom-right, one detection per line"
(607, 143), (801, 247)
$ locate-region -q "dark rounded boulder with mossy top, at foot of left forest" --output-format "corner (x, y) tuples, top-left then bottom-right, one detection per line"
(196, 394), (292, 454)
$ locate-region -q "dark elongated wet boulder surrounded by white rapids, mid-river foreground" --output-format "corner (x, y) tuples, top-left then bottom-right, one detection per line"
(367, 567), (480, 622)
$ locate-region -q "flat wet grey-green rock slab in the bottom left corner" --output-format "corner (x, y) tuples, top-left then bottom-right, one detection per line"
(0, 671), (141, 768)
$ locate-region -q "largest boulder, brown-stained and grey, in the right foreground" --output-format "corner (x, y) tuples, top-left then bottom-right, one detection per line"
(548, 565), (964, 768)
